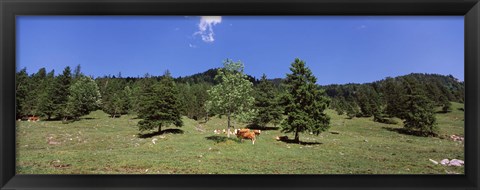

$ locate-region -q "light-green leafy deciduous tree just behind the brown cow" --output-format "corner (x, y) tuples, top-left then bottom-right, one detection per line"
(206, 59), (256, 137)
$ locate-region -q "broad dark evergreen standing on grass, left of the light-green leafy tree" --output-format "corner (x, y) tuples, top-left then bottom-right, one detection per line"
(138, 72), (183, 132)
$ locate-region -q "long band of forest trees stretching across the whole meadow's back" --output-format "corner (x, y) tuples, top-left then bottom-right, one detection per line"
(16, 62), (465, 137)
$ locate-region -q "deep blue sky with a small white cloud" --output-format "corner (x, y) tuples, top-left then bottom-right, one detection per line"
(17, 16), (464, 85)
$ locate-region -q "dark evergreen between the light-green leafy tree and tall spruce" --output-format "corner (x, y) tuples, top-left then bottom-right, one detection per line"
(253, 74), (282, 126)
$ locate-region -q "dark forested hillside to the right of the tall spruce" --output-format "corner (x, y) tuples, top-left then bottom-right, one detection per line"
(320, 73), (465, 120)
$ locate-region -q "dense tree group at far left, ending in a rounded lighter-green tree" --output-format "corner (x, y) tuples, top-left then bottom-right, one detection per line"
(16, 66), (101, 121)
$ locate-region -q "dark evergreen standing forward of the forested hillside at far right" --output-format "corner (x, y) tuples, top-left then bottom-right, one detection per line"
(402, 77), (438, 136)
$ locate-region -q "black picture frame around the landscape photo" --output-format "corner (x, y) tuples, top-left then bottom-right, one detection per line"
(0, 0), (480, 190)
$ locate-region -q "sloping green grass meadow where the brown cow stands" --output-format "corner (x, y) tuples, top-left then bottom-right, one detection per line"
(16, 103), (468, 174)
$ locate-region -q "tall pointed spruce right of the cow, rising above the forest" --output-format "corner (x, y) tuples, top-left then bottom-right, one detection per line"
(282, 58), (330, 142)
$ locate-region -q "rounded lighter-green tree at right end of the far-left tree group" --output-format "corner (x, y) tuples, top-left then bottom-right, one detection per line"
(63, 76), (101, 120)
